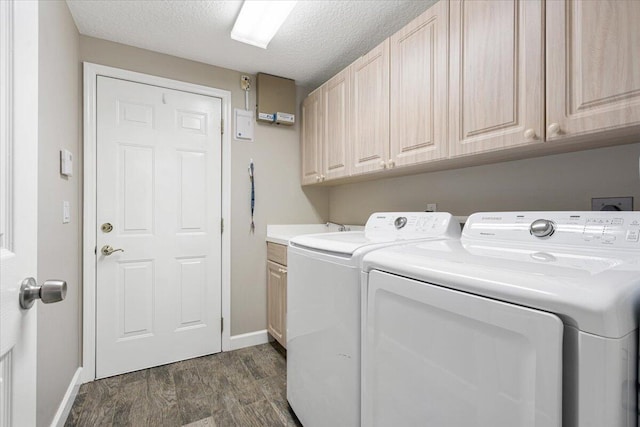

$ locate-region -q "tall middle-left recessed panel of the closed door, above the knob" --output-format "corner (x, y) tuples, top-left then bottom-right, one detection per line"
(119, 144), (154, 233)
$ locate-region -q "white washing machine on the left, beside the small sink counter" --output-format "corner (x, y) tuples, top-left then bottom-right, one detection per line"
(287, 212), (460, 427)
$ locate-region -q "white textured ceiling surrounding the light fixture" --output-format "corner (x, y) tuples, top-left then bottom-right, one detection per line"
(67, 0), (436, 88)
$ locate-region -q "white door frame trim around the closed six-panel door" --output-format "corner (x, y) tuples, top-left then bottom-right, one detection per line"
(82, 62), (231, 383)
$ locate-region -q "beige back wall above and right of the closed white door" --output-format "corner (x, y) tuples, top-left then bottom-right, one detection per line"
(80, 36), (329, 335)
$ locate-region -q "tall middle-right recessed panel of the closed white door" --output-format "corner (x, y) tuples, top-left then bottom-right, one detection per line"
(178, 151), (207, 231)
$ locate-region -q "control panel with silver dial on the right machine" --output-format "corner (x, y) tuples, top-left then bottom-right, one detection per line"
(462, 211), (640, 249)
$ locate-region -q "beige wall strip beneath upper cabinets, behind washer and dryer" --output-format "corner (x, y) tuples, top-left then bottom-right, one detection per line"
(329, 144), (640, 223)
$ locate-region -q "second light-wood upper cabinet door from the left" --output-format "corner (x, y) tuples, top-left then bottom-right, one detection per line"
(320, 68), (350, 181)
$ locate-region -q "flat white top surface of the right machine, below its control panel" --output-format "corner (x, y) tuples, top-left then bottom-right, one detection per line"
(363, 240), (640, 338)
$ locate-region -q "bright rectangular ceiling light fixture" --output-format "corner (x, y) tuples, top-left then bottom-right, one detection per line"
(231, 0), (297, 49)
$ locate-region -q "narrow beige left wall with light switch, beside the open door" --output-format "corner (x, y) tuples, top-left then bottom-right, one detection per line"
(36, 2), (82, 426)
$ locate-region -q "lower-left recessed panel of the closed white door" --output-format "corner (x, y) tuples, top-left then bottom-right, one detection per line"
(117, 260), (155, 338)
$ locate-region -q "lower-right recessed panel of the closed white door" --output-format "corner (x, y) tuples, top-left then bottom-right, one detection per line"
(178, 258), (206, 327)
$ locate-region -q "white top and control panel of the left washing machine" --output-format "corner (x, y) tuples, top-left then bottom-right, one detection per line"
(290, 212), (460, 256)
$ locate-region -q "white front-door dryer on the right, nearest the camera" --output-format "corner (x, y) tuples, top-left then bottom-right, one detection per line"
(362, 212), (640, 427)
